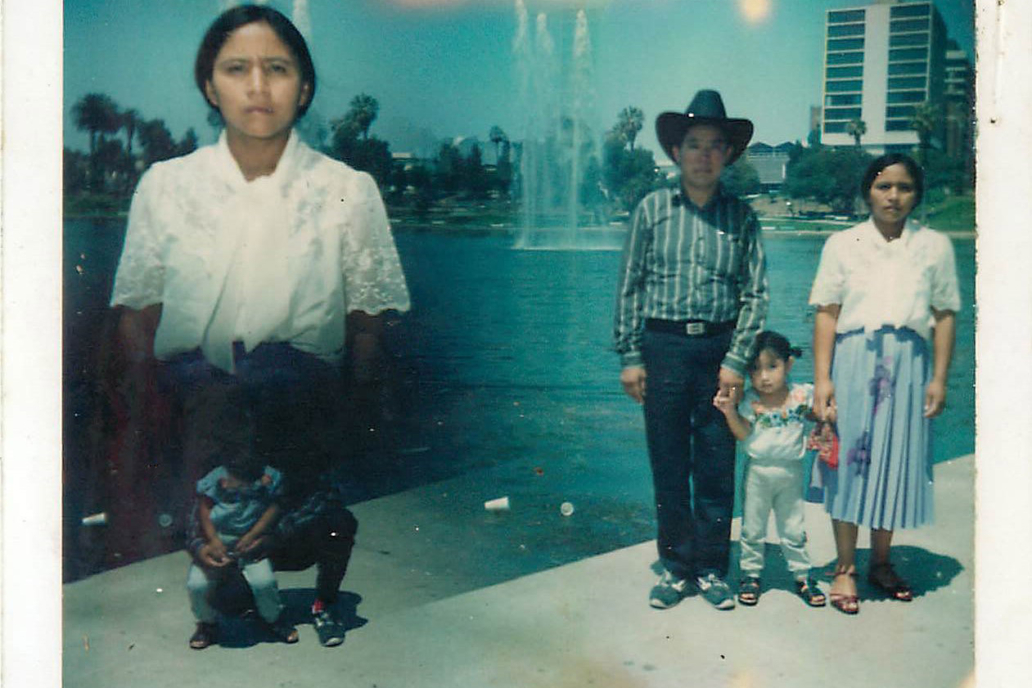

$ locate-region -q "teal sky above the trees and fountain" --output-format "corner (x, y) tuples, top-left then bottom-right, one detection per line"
(64, 0), (974, 159)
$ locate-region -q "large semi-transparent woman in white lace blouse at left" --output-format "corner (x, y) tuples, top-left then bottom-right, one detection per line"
(111, 5), (409, 647)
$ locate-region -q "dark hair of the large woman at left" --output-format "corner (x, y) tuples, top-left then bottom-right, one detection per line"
(194, 5), (316, 119)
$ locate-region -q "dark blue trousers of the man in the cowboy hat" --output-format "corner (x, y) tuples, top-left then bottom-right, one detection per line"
(642, 330), (735, 578)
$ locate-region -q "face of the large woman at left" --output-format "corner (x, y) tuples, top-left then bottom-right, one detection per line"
(205, 22), (309, 148)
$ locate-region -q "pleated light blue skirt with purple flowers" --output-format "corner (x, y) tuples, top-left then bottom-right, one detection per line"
(821, 327), (933, 530)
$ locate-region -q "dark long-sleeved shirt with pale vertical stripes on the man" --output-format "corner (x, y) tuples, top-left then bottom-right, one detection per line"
(614, 187), (769, 375)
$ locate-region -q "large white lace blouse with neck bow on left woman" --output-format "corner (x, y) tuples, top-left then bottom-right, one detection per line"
(111, 128), (409, 371)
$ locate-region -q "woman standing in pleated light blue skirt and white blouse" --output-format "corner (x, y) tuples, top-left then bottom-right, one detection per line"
(810, 155), (960, 614)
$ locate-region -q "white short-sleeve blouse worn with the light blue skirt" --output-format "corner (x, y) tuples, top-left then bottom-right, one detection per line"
(810, 221), (961, 339)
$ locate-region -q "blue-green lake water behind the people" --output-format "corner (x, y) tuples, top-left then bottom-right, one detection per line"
(64, 221), (974, 577)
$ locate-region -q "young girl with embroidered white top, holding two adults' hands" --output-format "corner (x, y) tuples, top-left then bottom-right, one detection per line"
(713, 332), (825, 607)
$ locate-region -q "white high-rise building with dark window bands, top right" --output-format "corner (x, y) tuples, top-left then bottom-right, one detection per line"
(820, 0), (946, 153)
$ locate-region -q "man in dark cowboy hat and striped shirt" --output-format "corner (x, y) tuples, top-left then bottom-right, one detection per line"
(614, 91), (768, 609)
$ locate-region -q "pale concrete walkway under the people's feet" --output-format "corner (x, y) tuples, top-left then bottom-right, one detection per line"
(63, 456), (974, 688)
